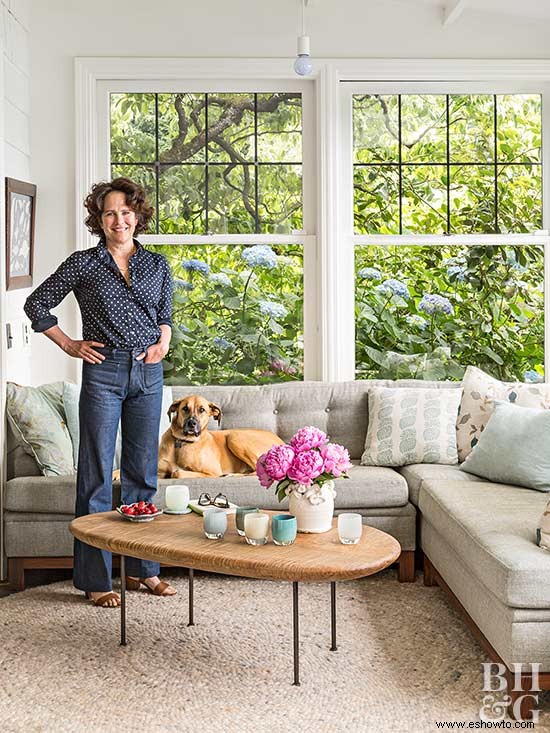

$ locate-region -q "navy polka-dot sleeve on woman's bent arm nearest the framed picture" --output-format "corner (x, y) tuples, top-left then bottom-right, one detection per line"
(24, 252), (80, 333)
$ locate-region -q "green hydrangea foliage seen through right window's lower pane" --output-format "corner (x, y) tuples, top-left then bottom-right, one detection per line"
(355, 246), (544, 380)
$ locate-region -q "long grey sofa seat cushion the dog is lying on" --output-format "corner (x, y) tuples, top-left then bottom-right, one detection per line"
(4, 461), (408, 514)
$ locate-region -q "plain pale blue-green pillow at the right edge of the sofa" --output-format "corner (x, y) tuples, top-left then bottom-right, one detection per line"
(460, 401), (550, 491)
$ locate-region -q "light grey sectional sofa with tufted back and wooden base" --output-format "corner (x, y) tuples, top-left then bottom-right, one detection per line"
(3, 380), (550, 715)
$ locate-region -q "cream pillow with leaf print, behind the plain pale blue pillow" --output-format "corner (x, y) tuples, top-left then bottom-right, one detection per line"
(456, 366), (550, 462)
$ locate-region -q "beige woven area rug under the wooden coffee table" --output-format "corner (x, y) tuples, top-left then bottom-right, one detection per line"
(0, 569), (550, 733)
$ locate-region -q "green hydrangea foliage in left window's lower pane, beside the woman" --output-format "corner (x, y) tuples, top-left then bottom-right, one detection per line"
(149, 245), (303, 384)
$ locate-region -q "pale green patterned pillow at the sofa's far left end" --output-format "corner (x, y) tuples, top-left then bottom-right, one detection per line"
(6, 382), (74, 476)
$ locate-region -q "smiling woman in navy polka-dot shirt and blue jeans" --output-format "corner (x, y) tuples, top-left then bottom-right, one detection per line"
(25, 178), (175, 607)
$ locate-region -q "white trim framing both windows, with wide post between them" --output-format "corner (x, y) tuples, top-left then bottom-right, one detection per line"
(75, 58), (550, 381)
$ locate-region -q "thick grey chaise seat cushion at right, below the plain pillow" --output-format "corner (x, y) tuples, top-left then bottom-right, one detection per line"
(419, 480), (550, 608)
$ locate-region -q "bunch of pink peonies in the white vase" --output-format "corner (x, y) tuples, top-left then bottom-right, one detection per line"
(256, 426), (351, 501)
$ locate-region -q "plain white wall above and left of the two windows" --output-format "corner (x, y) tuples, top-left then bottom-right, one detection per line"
(29, 0), (550, 383)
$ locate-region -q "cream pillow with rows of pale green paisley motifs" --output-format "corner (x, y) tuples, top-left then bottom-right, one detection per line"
(361, 387), (460, 466)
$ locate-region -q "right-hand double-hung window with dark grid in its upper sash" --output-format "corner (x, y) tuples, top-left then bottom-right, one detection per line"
(341, 82), (549, 381)
